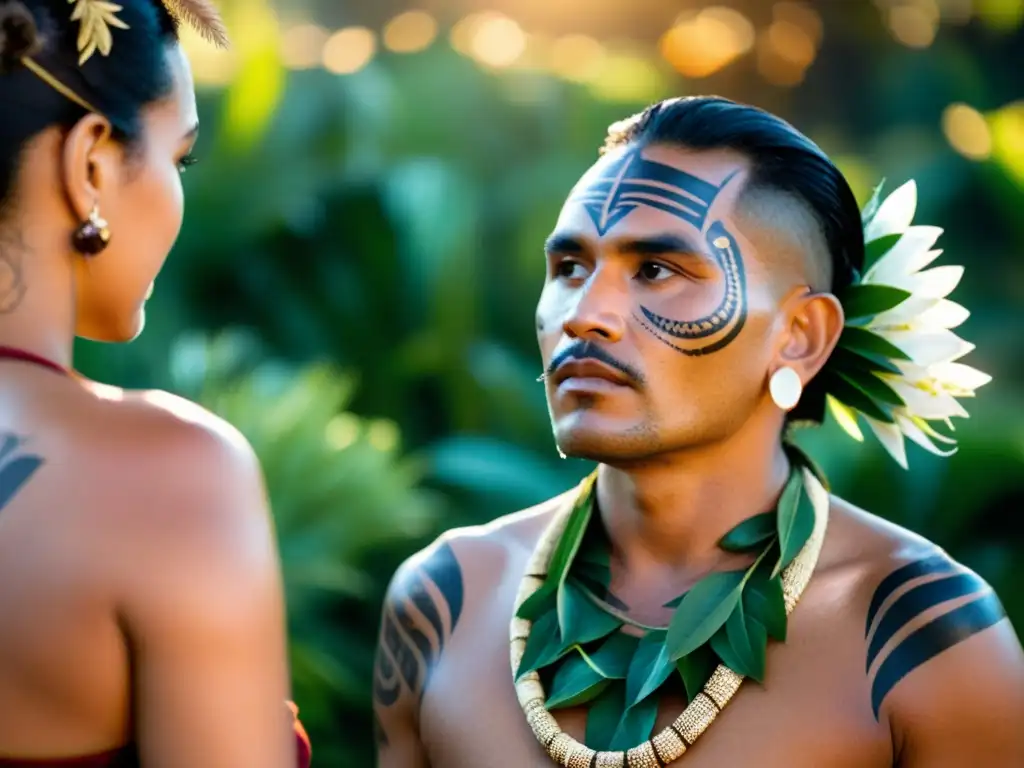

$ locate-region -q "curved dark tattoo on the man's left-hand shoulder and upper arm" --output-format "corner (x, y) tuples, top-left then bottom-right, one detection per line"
(374, 544), (463, 707)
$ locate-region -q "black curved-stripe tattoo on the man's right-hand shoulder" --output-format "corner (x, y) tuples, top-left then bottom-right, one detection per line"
(864, 554), (1006, 720)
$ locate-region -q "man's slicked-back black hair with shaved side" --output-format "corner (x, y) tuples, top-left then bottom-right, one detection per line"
(604, 96), (864, 423)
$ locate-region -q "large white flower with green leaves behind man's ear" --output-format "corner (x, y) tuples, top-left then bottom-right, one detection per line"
(827, 180), (991, 469)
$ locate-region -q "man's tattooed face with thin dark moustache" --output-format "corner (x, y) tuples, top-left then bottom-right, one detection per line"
(537, 144), (794, 463)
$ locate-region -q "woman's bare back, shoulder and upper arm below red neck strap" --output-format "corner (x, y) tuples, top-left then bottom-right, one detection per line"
(0, 360), (307, 765)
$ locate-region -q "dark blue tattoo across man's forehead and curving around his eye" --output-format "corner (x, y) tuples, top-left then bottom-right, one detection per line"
(571, 147), (746, 356)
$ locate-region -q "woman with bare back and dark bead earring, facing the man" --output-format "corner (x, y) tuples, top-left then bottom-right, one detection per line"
(0, 0), (309, 768)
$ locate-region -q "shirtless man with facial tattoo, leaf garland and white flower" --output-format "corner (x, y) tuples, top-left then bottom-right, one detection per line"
(374, 97), (1024, 768)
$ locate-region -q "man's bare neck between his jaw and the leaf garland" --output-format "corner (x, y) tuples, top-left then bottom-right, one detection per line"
(597, 427), (790, 574)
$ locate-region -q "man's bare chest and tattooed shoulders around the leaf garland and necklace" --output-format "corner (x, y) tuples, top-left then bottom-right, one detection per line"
(375, 489), (1024, 768)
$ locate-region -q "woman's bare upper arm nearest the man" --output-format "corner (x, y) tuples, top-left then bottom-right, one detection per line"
(119, 415), (296, 768)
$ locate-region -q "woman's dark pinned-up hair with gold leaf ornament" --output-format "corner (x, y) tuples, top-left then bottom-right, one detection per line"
(0, 0), (177, 209)
